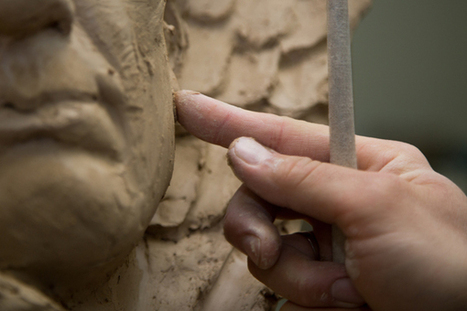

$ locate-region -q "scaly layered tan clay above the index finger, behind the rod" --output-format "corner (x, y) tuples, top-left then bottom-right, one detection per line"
(170, 0), (371, 119)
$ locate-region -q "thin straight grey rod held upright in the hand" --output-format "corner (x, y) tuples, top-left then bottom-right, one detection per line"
(327, 0), (357, 263)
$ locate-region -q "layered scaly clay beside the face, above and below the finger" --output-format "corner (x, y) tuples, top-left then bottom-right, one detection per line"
(147, 0), (371, 310)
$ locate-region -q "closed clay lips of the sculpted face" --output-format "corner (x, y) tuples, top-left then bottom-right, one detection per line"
(0, 100), (125, 160)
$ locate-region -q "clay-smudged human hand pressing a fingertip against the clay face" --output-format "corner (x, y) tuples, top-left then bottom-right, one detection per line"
(176, 91), (467, 311)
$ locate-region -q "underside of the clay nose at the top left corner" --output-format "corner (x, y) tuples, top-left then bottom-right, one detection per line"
(0, 0), (74, 38)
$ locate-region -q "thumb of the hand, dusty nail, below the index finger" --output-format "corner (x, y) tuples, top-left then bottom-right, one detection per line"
(228, 137), (402, 233)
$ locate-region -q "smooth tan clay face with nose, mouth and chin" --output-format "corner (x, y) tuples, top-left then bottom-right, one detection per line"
(0, 0), (174, 278)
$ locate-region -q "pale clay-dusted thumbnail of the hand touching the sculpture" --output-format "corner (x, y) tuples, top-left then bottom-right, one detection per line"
(232, 137), (272, 165)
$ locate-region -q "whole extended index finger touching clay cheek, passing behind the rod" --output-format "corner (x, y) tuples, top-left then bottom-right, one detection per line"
(174, 91), (429, 175)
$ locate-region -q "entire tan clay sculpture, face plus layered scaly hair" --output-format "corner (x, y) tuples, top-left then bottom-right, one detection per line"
(0, 0), (370, 311)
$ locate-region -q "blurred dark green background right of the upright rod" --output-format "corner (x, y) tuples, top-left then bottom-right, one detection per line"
(352, 0), (467, 191)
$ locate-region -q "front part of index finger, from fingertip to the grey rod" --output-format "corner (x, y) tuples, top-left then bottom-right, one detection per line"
(175, 91), (329, 162)
